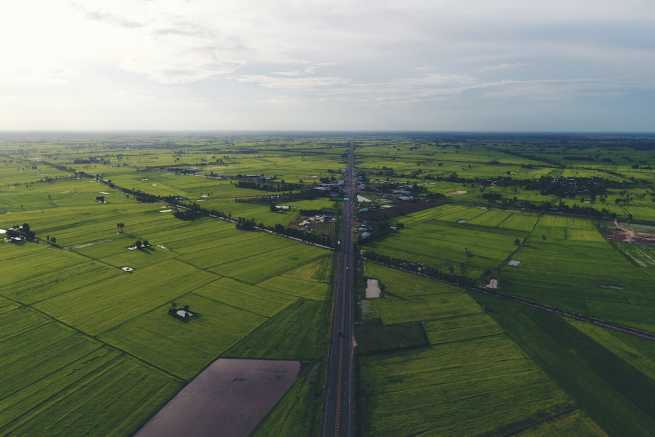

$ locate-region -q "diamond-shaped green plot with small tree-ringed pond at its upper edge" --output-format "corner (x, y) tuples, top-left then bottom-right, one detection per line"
(101, 294), (266, 378)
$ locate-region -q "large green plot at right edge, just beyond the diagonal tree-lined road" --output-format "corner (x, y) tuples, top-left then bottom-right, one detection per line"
(500, 216), (655, 329)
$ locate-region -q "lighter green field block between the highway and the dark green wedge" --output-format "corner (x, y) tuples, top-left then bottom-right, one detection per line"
(358, 263), (603, 436)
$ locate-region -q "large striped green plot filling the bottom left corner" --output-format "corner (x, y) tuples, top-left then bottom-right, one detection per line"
(0, 308), (178, 435)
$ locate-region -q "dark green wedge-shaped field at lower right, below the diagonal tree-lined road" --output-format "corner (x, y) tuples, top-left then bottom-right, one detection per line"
(478, 296), (655, 436)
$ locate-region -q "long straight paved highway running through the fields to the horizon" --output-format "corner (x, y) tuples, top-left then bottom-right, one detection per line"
(322, 146), (356, 437)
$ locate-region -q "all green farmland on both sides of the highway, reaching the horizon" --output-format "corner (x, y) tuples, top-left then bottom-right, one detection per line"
(0, 134), (655, 437)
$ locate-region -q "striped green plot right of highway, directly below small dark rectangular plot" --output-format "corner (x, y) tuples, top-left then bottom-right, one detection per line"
(362, 336), (570, 436)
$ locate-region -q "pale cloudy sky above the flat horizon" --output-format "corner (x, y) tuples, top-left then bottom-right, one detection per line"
(0, 0), (655, 132)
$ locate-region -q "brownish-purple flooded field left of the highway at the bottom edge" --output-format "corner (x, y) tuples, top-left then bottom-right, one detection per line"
(136, 359), (300, 437)
